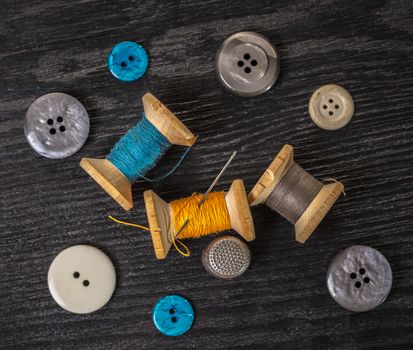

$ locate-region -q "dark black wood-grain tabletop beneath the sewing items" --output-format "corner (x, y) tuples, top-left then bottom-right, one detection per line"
(0, 0), (413, 350)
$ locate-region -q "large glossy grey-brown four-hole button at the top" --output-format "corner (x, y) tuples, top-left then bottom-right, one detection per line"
(215, 32), (280, 97)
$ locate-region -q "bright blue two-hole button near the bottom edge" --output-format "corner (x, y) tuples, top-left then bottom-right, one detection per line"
(153, 295), (194, 337)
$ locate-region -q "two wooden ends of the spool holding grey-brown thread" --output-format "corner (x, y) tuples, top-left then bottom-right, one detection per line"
(248, 145), (344, 243)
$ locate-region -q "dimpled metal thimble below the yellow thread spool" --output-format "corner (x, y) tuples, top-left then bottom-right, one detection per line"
(202, 236), (251, 278)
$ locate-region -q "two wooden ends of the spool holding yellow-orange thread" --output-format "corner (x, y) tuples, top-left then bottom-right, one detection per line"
(143, 180), (255, 259)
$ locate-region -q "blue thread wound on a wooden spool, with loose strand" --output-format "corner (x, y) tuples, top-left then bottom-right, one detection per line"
(106, 115), (190, 183)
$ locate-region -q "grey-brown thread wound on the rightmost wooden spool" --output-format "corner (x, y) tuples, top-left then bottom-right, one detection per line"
(265, 163), (323, 224)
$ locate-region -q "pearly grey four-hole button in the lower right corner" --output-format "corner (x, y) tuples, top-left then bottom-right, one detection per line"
(327, 245), (393, 312)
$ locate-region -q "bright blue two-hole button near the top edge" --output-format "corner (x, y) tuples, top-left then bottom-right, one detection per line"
(108, 41), (148, 81)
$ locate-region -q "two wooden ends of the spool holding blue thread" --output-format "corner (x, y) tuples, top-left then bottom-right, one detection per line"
(80, 92), (196, 210)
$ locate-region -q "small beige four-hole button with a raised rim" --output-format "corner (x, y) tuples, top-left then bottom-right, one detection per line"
(308, 84), (354, 130)
